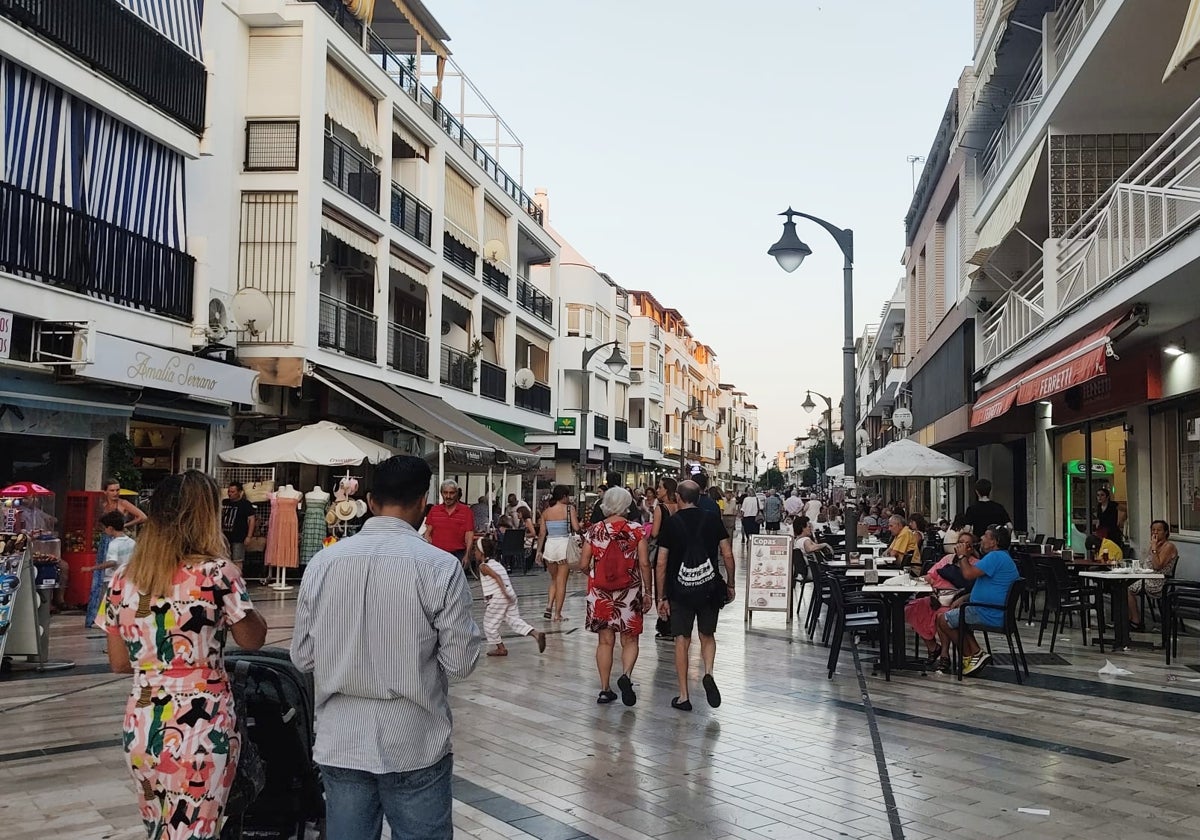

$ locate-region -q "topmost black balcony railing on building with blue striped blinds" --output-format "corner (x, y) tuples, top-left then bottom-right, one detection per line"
(0, 0), (209, 134)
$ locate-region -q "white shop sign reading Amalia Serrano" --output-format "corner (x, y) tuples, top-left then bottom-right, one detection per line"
(79, 332), (258, 404)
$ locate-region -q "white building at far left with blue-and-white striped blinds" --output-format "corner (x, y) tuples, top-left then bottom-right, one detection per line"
(0, 0), (256, 506)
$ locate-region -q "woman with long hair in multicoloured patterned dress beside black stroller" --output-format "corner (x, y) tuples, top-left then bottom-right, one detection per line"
(104, 470), (266, 840)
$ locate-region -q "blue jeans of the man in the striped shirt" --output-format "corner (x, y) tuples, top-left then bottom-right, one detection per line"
(320, 754), (454, 840)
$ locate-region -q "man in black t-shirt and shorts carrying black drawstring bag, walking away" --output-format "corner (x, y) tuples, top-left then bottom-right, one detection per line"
(655, 481), (734, 712)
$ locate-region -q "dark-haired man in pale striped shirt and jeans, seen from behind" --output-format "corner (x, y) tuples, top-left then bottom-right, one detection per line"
(292, 455), (484, 840)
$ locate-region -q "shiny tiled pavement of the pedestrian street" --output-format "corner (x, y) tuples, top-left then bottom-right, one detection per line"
(0, 544), (1200, 840)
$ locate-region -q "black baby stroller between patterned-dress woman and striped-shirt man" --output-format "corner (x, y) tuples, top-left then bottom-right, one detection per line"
(221, 648), (325, 840)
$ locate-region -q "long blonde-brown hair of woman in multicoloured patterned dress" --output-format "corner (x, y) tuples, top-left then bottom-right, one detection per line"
(125, 469), (228, 598)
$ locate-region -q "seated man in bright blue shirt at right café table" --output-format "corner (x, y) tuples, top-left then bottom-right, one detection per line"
(937, 526), (1021, 674)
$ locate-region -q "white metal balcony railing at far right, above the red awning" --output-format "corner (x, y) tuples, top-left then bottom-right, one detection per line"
(1056, 93), (1200, 307)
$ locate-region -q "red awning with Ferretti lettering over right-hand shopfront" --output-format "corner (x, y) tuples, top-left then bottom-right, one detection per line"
(971, 316), (1126, 427)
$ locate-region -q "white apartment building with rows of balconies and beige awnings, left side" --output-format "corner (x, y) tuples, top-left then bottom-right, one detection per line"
(190, 0), (558, 496)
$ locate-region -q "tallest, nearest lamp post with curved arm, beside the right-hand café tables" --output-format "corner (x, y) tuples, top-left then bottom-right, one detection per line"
(767, 208), (858, 550)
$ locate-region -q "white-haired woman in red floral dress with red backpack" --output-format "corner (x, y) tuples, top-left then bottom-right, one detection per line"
(580, 487), (654, 706)
